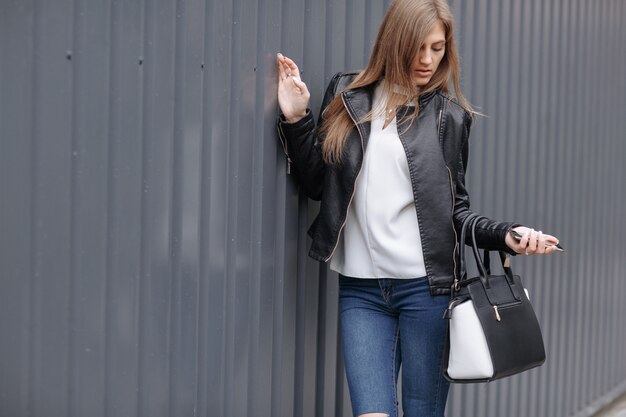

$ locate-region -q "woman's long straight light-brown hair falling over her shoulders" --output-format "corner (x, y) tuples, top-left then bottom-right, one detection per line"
(320, 0), (474, 164)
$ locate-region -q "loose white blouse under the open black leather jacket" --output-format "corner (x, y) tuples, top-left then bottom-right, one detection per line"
(330, 87), (426, 278)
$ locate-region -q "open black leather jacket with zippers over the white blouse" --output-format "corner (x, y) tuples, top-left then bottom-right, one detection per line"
(278, 72), (514, 294)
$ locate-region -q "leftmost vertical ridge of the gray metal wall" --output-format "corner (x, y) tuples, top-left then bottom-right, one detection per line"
(0, 2), (37, 415)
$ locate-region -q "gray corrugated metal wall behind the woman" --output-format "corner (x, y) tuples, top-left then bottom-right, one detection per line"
(0, 0), (626, 417)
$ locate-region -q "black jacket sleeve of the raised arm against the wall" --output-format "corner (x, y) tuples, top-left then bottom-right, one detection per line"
(277, 73), (341, 200)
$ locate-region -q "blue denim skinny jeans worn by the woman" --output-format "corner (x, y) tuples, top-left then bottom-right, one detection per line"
(339, 275), (450, 417)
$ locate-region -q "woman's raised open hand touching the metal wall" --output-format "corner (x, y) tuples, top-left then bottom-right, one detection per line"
(277, 53), (311, 123)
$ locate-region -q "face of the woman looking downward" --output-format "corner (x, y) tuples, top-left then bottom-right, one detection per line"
(411, 21), (446, 86)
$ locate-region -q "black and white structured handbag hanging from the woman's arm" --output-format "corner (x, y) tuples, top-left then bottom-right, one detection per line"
(443, 215), (546, 382)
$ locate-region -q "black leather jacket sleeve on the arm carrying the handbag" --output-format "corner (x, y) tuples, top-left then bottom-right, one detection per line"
(454, 113), (518, 255)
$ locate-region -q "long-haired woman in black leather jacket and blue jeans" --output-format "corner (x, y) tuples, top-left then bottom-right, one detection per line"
(278, 0), (558, 417)
